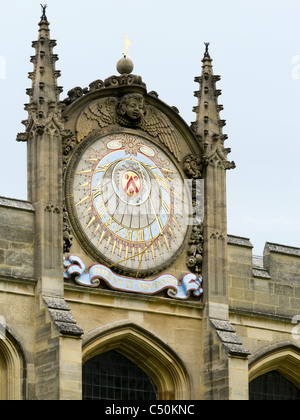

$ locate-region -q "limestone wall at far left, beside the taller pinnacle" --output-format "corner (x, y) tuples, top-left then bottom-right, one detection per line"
(0, 197), (35, 399)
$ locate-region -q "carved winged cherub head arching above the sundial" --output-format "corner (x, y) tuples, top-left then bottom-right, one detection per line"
(77, 93), (180, 161)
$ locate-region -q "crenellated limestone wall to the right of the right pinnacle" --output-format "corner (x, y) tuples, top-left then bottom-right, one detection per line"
(228, 236), (300, 386)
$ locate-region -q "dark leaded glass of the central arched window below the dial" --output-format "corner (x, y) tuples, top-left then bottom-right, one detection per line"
(82, 350), (157, 401)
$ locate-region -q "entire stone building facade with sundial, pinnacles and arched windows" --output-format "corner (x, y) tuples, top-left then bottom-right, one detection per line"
(0, 10), (300, 400)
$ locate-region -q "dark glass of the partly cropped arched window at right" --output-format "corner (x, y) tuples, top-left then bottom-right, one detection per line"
(249, 370), (300, 401)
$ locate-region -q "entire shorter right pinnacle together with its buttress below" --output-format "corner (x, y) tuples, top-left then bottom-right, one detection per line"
(192, 43), (248, 400)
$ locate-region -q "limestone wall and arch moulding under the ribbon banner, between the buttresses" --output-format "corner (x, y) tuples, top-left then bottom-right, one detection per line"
(65, 282), (203, 399)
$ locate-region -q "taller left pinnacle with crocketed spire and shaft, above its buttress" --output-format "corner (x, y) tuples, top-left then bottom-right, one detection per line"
(17, 5), (64, 296)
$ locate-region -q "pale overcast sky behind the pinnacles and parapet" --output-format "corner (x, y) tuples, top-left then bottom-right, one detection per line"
(0, 0), (300, 255)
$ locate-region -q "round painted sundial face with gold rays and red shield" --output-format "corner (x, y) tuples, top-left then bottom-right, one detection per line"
(72, 134), (190, 276)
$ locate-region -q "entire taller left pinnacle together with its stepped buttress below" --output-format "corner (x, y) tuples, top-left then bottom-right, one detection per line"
(17, 6), (83, 400)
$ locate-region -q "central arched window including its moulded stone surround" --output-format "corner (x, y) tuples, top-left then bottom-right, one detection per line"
(82, 320), (191, 400)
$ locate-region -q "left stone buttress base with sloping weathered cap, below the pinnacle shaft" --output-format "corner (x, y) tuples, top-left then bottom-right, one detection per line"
(35, 295), (83, 400)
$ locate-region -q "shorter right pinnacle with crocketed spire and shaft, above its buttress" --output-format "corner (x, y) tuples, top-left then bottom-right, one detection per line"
(192, 43), (235, 318)
